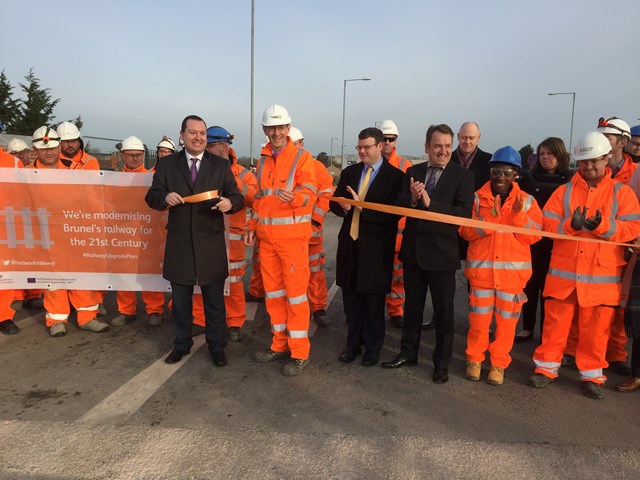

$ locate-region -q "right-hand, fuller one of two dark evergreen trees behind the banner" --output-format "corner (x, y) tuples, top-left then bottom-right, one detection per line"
(12, 69), (60, 135)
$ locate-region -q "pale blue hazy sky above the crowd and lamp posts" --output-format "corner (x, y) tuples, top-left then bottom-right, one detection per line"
(0, 0), (640, 161)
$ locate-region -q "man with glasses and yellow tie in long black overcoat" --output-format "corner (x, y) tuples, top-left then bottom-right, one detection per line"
(330, 128), (402, 367)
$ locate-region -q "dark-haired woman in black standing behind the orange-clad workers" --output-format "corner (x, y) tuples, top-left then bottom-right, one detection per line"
(515, 137), (574, 343)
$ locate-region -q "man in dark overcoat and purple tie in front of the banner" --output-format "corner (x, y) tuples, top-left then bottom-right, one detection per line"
(145, 115), (244, 367)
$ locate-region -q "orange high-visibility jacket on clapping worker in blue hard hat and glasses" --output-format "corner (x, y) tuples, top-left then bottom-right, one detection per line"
(458, 182), (542, 292)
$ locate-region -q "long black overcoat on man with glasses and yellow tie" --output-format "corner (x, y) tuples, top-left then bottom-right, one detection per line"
(330, 159), (403, 295)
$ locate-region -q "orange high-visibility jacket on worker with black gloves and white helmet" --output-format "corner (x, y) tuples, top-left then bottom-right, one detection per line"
(543, 167), (640, 307)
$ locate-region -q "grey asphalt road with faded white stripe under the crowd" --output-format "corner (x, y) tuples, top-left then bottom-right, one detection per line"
(0, 215), (640, 479)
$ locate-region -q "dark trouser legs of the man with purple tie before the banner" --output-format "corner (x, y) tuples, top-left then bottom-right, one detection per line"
(171, 281), (227, 352)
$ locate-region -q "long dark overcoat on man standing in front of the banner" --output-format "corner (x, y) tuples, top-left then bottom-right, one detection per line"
(145, 150), (244, 285)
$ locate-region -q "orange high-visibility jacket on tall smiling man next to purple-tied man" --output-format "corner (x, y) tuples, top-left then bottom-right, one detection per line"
(253, 141), (317, 242)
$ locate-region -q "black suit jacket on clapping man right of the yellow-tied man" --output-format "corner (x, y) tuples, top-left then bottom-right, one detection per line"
(398, 162), (475, 271)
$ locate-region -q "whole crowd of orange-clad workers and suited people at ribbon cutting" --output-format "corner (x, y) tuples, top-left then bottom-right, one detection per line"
(0, 105), (640, 399)
